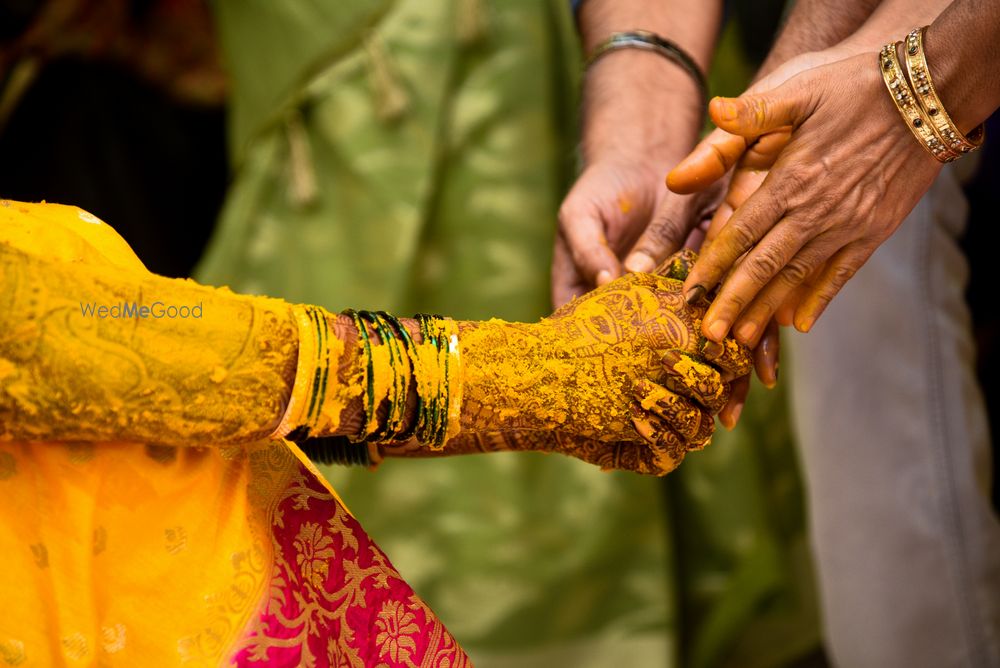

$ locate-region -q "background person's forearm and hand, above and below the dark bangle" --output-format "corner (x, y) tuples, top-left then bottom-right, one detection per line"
(552, 0), (722, 307)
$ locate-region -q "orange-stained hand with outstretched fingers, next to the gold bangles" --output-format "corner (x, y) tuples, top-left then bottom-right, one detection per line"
(668, 53), (940, 345)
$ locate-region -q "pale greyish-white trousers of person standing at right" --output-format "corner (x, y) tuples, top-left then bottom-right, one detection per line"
(786, 169), (1000, 668)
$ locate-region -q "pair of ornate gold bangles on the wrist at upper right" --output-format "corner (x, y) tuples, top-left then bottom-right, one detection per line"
(878, 26), (986, 162)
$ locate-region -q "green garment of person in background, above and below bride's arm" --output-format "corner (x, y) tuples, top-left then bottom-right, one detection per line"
(197, 0), (816, 668)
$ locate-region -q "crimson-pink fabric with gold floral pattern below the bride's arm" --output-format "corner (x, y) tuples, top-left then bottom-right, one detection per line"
(231, 466), (472, 668)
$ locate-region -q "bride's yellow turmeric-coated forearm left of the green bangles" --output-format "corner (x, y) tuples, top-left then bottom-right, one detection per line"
(0, 237), (297, 445)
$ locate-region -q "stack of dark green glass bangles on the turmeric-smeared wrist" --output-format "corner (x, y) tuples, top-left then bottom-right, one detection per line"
(274, 306), (462, 466)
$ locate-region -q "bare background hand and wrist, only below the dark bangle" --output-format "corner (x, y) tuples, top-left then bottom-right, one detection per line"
(552, 51), (703, 307)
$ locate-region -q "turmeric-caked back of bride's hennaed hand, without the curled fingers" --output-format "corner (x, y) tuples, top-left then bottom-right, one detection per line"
(461, 250), (748, 441)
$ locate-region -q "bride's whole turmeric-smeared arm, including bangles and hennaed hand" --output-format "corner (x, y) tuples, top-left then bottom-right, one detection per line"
(0, 231), (728, 474)
